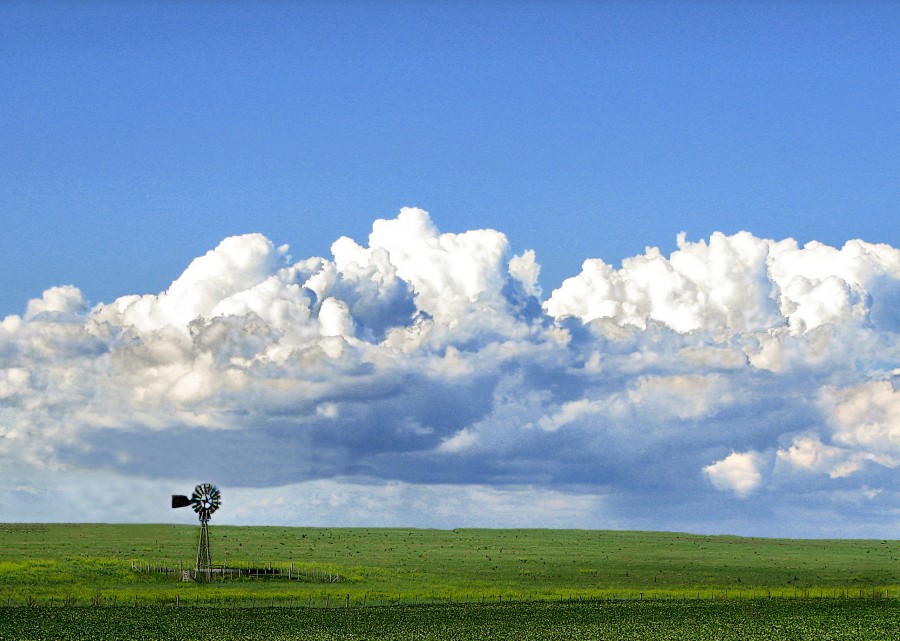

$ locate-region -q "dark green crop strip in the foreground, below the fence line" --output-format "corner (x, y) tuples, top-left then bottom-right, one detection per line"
(0, 599), (900, 641)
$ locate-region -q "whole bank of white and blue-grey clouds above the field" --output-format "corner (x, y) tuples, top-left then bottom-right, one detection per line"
(0, 208), (900, 536)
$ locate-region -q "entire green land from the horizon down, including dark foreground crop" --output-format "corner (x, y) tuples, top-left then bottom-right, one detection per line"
(0, 524), (900, 641)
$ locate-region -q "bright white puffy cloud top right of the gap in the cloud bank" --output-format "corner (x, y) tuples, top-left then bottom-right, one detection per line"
(544, 232), (900, 334)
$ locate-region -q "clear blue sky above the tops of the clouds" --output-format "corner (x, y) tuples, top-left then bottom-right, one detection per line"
(0, 2), (900, 313)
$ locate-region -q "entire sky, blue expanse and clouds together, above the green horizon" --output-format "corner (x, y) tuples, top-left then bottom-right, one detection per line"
(0, 1), (900, 538)
